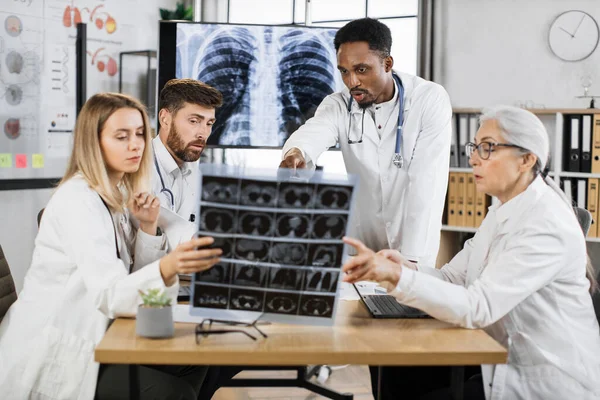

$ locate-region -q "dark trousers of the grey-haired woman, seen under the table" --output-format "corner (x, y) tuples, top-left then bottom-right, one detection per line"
(369, 366), (485, 400)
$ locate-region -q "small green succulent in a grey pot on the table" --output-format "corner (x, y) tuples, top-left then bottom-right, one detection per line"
(135, 289), (174, 338)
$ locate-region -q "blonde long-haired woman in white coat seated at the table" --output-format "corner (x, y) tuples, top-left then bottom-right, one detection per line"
(0, 93), (220, 399)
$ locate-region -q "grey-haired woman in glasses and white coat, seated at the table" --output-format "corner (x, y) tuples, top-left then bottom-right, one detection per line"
(343, 106), (600, 400)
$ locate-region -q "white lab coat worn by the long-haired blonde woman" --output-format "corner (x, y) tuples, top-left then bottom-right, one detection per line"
(0, 176), (179, 400)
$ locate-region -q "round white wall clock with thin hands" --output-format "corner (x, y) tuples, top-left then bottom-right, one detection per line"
(548, 10), (600, 61)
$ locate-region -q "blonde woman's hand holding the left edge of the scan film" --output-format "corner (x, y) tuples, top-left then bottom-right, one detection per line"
(159, 236), (223, 286)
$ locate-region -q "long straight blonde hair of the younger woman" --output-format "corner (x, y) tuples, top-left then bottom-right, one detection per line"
(59, 93), (152, 212)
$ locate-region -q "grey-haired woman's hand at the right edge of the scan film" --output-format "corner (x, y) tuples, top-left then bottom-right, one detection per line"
(342, 237), (402, 290)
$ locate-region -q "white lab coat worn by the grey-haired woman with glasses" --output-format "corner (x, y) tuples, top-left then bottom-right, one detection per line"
(391, 177), (600, 400)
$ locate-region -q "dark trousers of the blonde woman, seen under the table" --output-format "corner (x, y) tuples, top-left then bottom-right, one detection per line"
(95, 364), (208, 400)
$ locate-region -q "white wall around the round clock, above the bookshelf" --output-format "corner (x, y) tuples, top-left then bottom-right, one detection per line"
(435, 0), (600, 108)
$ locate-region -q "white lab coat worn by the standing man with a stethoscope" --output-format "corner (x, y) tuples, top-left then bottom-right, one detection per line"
(283, 73), (452, 265)
